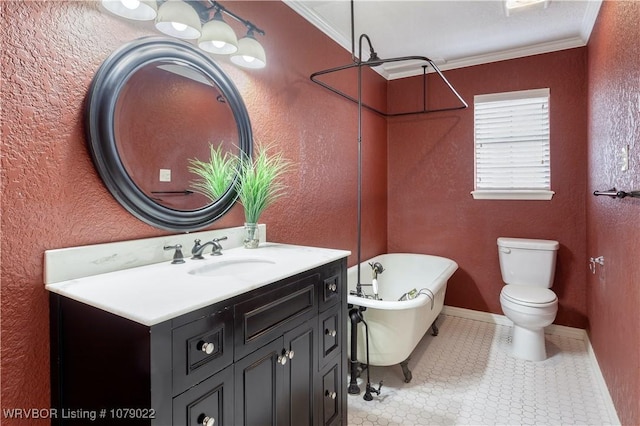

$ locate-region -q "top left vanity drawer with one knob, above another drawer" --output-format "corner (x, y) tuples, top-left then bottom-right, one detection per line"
(171, 309), (233, 395)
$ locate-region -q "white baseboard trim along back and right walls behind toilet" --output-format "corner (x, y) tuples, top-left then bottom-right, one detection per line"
(442, 305), (620, 425)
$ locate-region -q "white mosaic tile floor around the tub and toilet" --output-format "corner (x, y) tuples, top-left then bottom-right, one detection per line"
(347, 315), (618, 426)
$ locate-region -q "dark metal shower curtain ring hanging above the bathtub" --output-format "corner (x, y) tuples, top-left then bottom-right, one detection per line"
(310, 56), (469, 117)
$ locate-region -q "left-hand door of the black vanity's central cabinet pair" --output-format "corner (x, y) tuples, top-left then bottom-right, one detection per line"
(235, 337), (286, 426)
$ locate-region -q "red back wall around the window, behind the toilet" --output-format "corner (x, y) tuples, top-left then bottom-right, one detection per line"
(388, 48), (587, 327)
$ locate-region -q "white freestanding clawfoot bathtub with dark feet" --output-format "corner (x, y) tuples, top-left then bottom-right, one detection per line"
(347, 253), (458, 382)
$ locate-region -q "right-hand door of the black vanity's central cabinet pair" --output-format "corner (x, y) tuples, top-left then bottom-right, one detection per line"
(278, 320), (318, 426)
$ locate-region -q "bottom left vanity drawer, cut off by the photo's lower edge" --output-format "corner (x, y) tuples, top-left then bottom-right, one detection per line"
(173, 365), (235, 426)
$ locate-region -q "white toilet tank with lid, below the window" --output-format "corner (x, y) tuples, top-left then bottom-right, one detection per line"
(498, 237), (560, 288)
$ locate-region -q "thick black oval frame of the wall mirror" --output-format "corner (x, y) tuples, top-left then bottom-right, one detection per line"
(85, 37), (253, 232)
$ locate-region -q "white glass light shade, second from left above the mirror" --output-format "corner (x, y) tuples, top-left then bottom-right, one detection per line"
(156, 0), (202, 40)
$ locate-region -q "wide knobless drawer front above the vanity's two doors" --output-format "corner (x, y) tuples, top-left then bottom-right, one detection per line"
(235, 274), (320, 360)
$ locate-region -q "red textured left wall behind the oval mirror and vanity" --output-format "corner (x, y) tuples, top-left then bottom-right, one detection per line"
(0, 1), (386, 425)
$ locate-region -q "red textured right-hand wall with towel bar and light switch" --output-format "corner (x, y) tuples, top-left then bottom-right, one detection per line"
(586, 1), (640, 425)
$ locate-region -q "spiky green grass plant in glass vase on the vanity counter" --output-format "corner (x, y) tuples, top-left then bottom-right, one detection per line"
(235, 146), (291, 248)
